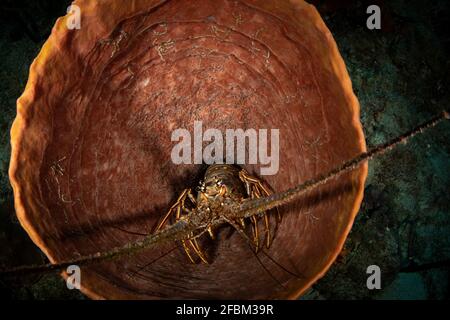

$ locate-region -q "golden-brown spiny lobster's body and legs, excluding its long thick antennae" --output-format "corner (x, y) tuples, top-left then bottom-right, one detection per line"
(156, 164), (281, 263)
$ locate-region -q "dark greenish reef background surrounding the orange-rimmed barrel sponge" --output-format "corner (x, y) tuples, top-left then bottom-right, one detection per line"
(0, 0), (450, 299)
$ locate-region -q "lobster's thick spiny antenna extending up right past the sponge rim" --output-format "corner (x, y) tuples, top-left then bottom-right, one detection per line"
(235, 110), (450, 218)
